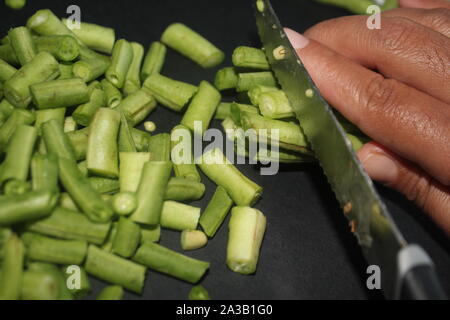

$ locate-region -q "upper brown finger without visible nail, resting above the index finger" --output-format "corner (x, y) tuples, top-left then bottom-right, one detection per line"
(305, 16), (450, 103)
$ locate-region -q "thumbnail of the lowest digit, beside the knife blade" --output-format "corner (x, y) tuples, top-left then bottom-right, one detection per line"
(362, 153), (398, 184)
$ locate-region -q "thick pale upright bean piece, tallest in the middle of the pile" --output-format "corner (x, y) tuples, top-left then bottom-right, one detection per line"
(86, 108), (120, 178)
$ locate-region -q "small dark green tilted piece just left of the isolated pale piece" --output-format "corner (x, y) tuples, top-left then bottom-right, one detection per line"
(199, 186), (233, 238)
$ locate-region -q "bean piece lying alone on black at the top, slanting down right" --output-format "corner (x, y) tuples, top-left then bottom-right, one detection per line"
(161, 23), (225, 68)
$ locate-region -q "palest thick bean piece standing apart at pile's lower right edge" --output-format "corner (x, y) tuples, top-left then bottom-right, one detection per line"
(227, 207), (266, 274)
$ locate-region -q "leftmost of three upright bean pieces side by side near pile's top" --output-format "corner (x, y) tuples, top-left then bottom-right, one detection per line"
(106, 39), (133, 89)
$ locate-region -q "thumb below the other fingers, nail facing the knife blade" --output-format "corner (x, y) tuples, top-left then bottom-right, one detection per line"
(358, 143), (450, 236)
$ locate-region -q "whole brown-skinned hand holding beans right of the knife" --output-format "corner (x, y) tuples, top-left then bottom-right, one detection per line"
(286, 0), (450, 236)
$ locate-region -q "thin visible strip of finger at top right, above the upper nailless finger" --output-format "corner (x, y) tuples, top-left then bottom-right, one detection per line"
(382, 8), (450, 37)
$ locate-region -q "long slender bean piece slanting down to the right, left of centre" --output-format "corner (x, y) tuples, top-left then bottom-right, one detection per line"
(58, 158), (113, 222)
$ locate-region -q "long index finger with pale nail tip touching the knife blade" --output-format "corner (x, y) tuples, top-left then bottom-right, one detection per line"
(286, 29), (450, 185)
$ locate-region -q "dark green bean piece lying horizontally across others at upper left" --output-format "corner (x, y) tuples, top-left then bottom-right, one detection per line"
(30, 78), (89, 109)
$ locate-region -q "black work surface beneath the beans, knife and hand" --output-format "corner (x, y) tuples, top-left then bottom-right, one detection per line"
(0, 0), (450, 299)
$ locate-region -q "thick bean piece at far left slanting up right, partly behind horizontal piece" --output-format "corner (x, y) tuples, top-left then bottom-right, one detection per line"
(4, 52), (59, 108)
